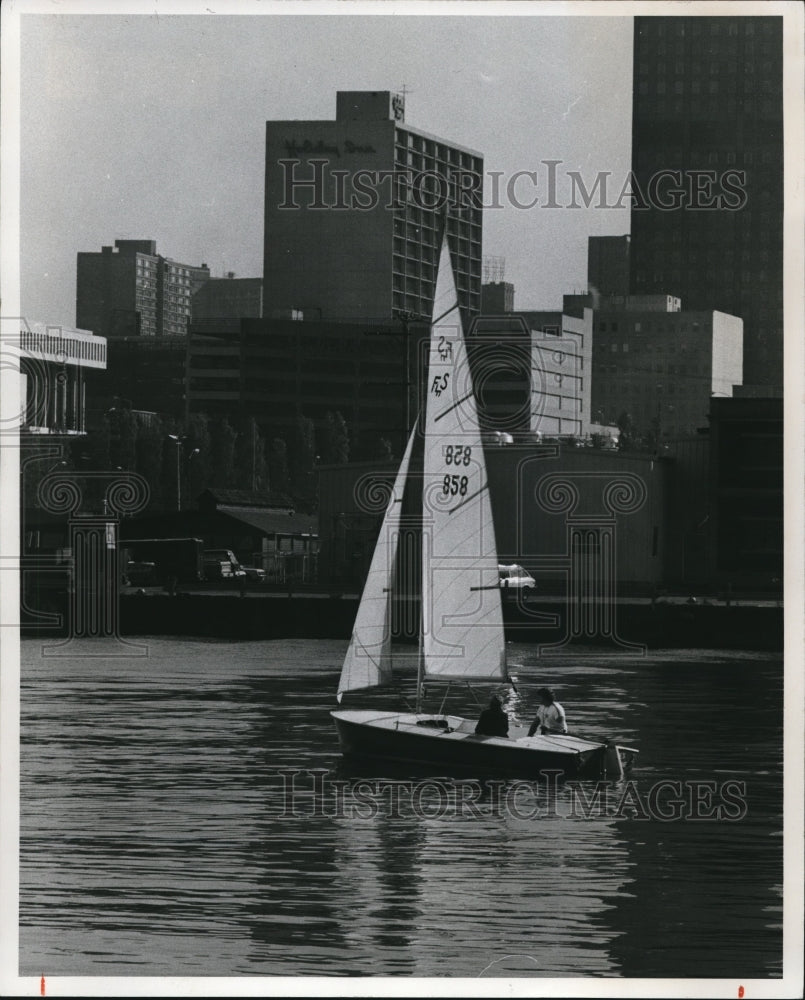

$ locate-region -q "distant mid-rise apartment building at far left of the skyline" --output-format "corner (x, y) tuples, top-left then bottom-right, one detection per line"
(76, 240), (210, 338)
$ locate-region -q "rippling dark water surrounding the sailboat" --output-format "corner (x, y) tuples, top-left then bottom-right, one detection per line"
(20, 639), (783, 979)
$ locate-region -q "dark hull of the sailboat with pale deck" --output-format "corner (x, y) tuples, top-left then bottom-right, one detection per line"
(331, 711), (623, 778)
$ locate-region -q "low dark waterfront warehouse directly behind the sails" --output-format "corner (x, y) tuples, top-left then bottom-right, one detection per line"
(319, 442), (670, 597)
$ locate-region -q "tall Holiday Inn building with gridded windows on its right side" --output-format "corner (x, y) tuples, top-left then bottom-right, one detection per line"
(263, 91), (483, 324)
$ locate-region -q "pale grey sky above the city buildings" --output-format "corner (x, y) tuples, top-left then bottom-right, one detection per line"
(20, 5), (633, 326)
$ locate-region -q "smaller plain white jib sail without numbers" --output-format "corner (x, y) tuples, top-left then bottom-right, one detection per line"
(338, 432), (415, 702)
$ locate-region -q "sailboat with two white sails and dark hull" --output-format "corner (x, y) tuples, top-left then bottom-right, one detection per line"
(331, 239), (633, 777)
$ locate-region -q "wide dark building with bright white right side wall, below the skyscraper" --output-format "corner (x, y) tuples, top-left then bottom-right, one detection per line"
(592, 295), (743, 438)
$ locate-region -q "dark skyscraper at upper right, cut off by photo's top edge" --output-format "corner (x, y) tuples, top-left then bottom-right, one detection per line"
(631, 16), (783, 394)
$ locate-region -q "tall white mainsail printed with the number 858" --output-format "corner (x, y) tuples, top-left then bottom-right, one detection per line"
(422, 240), (508, 681)
